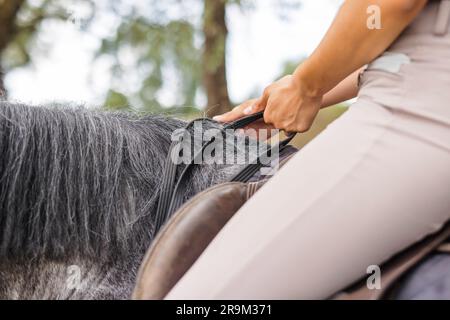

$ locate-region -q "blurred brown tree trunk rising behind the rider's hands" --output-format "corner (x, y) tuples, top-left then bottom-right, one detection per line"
(202, 0), (231, 116)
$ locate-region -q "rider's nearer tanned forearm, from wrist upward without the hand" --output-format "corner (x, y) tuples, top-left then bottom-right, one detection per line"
(294, 0), (427, 96)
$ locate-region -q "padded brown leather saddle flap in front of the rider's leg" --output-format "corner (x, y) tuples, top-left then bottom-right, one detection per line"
(133, 182), (258, 299)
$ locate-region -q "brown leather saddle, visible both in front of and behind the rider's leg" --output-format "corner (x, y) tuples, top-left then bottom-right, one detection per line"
(132, 113), (450, 300)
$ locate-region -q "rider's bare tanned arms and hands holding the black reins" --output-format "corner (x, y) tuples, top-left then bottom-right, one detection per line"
(216, 0), (427, 132)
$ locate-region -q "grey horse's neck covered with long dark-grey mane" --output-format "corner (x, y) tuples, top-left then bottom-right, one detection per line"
(0, 102), (250, 299)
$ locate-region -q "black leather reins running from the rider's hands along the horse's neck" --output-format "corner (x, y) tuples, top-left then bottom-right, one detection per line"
(155, 111), (295, 234)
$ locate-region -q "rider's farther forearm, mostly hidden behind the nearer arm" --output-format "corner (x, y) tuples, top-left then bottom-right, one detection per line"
(322, 67), (364, 108)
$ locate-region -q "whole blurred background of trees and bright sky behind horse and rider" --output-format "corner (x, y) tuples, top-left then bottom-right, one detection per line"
(0, 0), (346, 146)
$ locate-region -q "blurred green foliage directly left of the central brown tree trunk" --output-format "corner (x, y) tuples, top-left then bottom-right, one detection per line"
(97, 0), (201, 113)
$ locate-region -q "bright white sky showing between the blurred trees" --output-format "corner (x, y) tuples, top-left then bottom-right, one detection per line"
(5, 0), (342, 105)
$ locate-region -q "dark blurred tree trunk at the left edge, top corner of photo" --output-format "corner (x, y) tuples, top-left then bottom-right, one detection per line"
(0, 0), (25, 98)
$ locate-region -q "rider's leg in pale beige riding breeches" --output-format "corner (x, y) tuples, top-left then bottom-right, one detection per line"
(167, 101), (450, 299)
